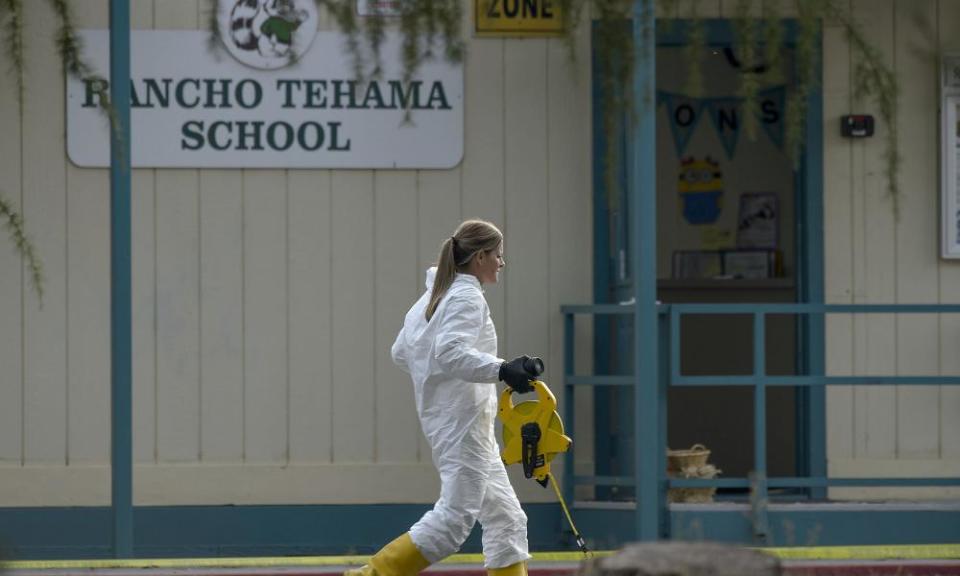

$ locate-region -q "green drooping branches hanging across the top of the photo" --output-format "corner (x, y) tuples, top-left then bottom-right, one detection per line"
(0, 0), (900, 257)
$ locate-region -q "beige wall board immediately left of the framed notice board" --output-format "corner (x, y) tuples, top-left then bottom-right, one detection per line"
(895, 0), (940, 458)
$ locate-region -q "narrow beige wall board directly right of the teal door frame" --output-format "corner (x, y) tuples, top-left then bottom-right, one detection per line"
(823, 13), (854, 458)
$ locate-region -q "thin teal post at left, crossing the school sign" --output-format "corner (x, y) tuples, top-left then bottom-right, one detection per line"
(110, 0), (133, 558)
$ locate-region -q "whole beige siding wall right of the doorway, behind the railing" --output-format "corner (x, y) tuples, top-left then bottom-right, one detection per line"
(824, 0), (960, 498)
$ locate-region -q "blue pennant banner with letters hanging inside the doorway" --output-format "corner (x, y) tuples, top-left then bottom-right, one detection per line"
(657, 86), (786, 158)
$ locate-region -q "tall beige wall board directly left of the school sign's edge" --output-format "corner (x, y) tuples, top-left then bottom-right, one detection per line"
(22, 2), (67, 464)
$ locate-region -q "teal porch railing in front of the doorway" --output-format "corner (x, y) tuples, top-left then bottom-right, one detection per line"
(561, 303), (960, 531)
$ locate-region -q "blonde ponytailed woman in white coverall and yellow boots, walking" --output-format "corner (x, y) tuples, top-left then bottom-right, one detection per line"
(346, 220), (535, 576)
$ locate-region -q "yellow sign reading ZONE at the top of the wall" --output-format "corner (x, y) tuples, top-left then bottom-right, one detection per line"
(473, 0), (563, 36)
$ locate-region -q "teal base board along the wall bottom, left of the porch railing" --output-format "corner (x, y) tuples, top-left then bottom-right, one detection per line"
(0, 504), (576, 560)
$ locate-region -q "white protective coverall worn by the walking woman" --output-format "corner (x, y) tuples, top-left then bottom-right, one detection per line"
(391, 268), (530, 569)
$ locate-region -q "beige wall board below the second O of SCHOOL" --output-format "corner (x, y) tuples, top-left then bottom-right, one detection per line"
(287, 170), (333, 462)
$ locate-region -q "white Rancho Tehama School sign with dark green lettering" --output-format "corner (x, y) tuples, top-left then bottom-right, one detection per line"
(67, 29), (464, 168)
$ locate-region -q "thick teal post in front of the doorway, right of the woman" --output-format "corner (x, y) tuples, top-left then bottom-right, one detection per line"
(631, 0), (664, 540)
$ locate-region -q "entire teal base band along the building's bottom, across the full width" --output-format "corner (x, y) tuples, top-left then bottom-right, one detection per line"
(0, 502), (960, 560)
